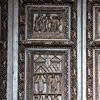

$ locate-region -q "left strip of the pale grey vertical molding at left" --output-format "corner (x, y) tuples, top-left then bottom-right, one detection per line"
(7, 0), (13, 100)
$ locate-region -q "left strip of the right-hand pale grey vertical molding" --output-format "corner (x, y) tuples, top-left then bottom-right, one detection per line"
(77, 0), (82, 100)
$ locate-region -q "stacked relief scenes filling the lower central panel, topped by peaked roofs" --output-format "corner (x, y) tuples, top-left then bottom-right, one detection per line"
(27, 49), (69, 100)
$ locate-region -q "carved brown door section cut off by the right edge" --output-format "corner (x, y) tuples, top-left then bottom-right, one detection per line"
(87, 0), (100, 100)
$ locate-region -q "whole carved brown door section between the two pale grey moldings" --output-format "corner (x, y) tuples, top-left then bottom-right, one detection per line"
(18, 0), (77, 100)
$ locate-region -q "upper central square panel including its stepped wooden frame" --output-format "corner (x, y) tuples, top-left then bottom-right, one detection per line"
(26, 5), (71, 40)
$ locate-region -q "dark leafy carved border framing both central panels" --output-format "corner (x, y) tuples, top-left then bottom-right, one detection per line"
(18, 0), (77, 100)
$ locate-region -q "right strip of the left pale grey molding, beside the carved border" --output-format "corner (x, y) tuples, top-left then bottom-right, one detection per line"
(13, 0), (18, 100)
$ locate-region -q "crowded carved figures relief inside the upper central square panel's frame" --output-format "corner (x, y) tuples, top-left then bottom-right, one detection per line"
(33, 14), (62, 33)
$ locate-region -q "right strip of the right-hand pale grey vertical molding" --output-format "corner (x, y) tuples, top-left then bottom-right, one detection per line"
(82, 0), (87, 100)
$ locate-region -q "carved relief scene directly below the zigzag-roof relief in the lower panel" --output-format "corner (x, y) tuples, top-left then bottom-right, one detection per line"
(34, 75), (61, 94)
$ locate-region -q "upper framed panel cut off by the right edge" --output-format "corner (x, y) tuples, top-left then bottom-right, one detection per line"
(93, 6), (100, 41)
